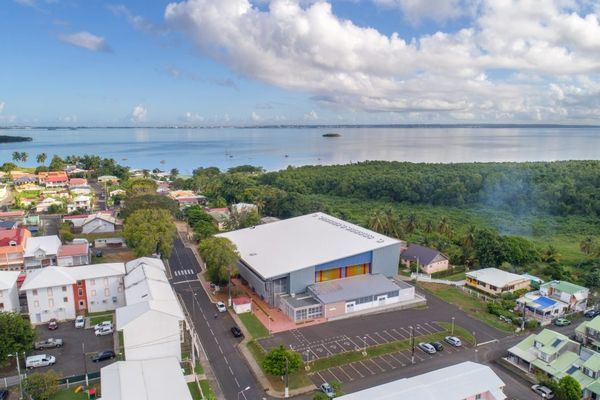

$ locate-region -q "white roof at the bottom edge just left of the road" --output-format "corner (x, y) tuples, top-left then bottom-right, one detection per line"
(100, 357), (192, 400)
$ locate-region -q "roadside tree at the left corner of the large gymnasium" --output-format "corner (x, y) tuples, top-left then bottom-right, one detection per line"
(199, 237), (239, 284)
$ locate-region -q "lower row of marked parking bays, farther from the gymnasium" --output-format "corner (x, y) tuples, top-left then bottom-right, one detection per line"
(309, 338), (469, 386)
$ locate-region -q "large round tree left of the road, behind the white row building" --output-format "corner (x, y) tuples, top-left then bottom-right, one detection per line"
(123, 209), (177, 258)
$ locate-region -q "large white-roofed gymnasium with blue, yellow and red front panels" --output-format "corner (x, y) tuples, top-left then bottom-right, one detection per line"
(217, 212), (414, 321)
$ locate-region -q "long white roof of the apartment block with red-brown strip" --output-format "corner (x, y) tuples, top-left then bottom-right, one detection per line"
(21, 263), (125, 290)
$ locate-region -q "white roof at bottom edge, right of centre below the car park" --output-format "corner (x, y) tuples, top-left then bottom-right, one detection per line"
(337, 361), (506, 400)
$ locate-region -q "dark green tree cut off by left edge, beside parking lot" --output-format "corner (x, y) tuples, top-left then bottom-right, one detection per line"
(0, 312), (35, 364)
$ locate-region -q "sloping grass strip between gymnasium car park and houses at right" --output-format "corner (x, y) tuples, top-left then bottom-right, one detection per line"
(419, 282), (514, 332)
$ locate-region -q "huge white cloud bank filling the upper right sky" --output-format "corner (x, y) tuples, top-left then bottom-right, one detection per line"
(165, 0), (600, 121)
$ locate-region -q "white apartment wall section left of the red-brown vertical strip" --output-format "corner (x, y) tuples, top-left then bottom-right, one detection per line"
(27, 285), (75, 325)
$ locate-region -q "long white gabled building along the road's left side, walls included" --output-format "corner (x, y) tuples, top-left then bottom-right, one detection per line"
(117, 258), (185, 361)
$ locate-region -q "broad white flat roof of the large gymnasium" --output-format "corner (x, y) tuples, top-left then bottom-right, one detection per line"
(216, 212), (400, 279)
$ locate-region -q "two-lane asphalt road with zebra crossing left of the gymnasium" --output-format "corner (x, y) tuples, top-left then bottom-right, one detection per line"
(169, 238), (267, 400)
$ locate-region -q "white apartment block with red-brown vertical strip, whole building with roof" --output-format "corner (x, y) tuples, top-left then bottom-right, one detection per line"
(21, 263), (125, 324)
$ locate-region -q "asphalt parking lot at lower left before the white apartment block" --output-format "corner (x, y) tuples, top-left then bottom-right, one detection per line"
(20, 321), (115, 376)
